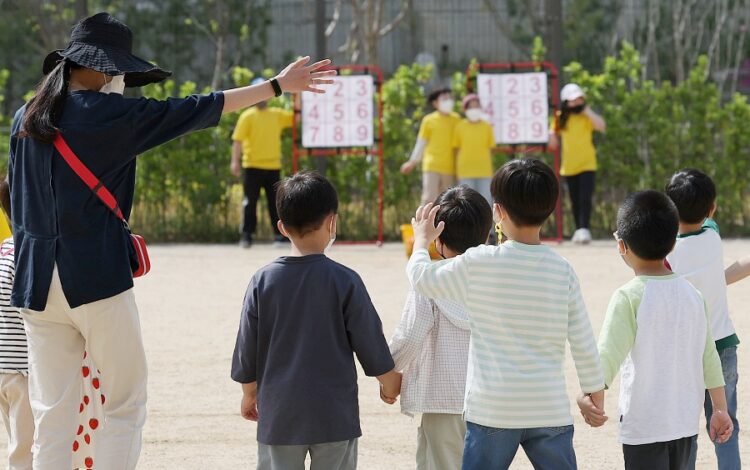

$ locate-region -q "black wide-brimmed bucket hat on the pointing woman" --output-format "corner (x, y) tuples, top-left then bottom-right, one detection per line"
(42, 13), (172, 87)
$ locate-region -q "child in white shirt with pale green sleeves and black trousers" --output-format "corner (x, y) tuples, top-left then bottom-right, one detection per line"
(579, 191), (732, 470)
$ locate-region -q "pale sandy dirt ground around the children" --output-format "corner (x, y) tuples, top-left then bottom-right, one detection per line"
(2, 240), (750, 470)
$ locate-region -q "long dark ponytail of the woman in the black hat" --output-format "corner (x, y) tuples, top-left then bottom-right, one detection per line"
(19, 59), (80, 143)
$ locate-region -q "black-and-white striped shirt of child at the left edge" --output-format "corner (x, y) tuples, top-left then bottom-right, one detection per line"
(0, 238), (29, 375)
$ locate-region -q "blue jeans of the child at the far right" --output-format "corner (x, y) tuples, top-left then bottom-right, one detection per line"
(691, 346), (742, 470)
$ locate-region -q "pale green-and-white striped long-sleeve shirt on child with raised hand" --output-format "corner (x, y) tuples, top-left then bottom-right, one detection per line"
(407, 241), (604, 428)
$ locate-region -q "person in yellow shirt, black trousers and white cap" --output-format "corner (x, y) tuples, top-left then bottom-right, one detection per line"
(548, 83), (607, 244)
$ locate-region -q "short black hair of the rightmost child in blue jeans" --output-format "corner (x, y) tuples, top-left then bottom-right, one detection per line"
(665, 168), (716, 224)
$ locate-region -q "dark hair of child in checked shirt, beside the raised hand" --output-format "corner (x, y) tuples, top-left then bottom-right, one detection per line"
(435, 185), (492, 254)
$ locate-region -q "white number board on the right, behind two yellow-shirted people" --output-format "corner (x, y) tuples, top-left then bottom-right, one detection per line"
(477, 72), (549, 144)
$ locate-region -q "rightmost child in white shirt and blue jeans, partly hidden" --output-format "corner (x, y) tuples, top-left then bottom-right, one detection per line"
(666, 169), (741, 470)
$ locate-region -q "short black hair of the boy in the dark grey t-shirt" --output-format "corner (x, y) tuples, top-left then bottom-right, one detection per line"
(276, 171), (339, 236)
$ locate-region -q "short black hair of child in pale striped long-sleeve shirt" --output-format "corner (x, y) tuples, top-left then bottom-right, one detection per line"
(491, 158), (560, 226)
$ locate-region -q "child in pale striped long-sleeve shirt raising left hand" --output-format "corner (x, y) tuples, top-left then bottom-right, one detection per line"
(407, 159), (604, 470)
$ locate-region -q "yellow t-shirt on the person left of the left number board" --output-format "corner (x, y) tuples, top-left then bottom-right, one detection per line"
(232, 107), (294, 170)
